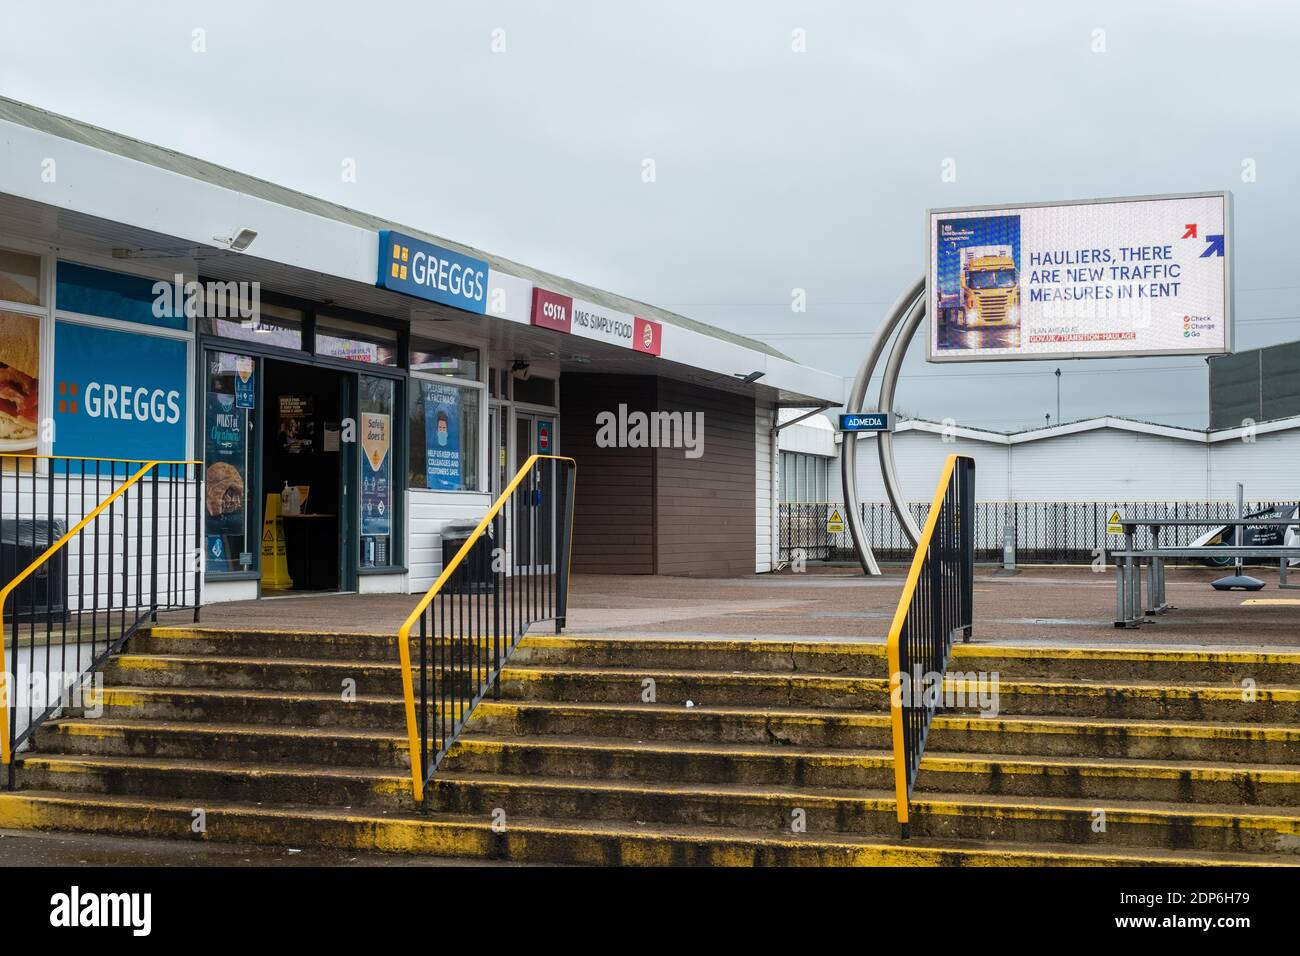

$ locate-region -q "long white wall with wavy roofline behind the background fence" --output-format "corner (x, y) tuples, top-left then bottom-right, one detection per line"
(842, 428), (1300, 502)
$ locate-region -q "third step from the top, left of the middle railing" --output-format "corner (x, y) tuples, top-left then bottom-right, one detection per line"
(85, 685), (406, 731)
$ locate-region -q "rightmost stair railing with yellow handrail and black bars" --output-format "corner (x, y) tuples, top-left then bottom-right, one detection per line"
(885, 455), (975, 836)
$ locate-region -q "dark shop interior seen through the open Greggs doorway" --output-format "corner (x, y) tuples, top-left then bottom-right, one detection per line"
(261, 359), (346, 593)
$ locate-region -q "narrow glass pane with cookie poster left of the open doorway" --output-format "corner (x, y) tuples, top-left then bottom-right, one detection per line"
(203, 351), (257, 574)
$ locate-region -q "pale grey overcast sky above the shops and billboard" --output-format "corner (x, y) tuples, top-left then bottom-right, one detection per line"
(0, 0), (1300, 429)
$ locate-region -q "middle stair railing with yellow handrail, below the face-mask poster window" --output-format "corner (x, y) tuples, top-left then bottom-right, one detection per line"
(398, 455), (577, 803)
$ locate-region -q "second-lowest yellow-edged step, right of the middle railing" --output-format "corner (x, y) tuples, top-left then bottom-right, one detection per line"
(430, 773), (1300, 864)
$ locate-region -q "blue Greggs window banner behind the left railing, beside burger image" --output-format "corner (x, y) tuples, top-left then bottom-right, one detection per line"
(53, 321), (190, 460)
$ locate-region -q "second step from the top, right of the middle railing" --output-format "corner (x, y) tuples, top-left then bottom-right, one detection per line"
(501, 665), (1300, 723)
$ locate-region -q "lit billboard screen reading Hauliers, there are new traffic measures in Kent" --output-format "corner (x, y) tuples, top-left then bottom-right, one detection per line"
(927, 193), (1232, 362)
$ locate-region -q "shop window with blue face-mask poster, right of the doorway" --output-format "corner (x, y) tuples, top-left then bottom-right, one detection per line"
(410, 377), (482, 492)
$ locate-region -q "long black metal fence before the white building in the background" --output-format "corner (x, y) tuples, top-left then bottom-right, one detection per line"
(780, 501), (1295, 564)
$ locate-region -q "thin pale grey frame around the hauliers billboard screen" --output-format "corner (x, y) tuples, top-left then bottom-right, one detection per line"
(924, 190), (1236, 364)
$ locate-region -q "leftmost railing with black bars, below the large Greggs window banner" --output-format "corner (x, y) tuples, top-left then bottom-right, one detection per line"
(0, 455), (203, 788)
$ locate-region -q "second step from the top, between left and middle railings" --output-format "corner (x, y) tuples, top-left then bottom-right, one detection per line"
(104, 654), (475, 695)
